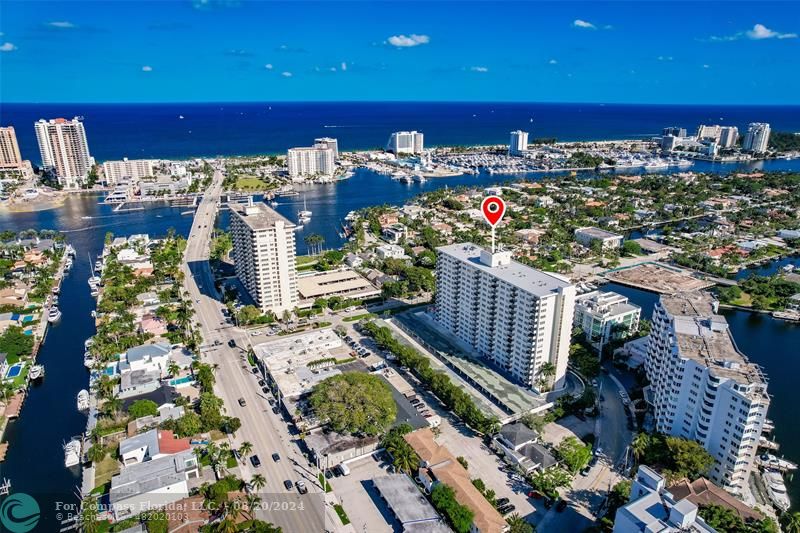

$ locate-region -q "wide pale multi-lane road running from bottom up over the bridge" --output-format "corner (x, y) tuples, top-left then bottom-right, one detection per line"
(182, 169), (338, 533)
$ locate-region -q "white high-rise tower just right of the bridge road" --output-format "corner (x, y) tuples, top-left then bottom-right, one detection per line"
(230, 200), (298, 317)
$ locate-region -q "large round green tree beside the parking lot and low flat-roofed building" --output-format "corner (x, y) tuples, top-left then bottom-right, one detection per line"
(309, 372), (397, 435)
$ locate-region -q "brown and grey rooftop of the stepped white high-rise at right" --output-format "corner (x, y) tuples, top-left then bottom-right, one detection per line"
(660, 291), (765, 384)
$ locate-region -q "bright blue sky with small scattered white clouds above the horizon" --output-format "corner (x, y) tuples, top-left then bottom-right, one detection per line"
(0, 0), (800, 104)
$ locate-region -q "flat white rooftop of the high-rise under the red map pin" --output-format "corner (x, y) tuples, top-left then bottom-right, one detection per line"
(436, 242), (572, 296)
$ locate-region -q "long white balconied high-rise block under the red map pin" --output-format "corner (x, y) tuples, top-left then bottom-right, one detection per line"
(434, 243), (575, 388)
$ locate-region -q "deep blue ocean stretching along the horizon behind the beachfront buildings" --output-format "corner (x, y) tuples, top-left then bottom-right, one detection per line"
(0, 102), (800, 162)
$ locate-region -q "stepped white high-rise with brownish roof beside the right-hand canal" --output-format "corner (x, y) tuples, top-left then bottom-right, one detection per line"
(645, 292), (770, 494)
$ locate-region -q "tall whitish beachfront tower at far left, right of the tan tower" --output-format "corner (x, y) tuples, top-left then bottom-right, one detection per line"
(34, 117), (94, 189)
